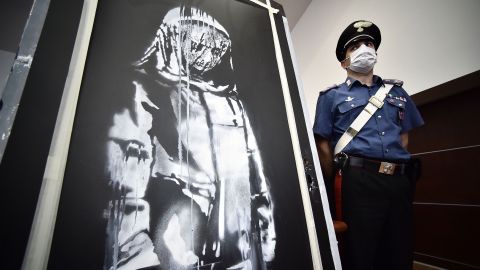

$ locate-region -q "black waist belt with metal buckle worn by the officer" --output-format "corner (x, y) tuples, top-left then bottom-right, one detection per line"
(348, 156), (408, 175)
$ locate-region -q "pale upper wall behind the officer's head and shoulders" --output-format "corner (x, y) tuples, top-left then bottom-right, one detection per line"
(292, 0), (480, 119)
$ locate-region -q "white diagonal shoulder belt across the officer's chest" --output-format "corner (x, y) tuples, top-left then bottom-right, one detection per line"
(334, 84), (393, 155)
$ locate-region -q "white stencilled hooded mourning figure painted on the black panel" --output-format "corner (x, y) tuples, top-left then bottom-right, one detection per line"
(104, 7), (276, 269)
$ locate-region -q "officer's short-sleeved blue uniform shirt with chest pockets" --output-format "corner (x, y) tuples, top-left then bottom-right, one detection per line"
(313, 76), (424, 161)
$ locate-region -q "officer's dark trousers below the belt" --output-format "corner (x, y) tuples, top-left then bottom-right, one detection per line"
(342, 166), (414, 270)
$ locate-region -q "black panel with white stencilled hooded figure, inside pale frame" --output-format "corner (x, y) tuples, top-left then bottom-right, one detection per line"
(48, 0), (322, 269)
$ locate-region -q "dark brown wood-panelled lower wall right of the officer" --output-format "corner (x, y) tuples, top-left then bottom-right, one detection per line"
(409, 71), (480, 270)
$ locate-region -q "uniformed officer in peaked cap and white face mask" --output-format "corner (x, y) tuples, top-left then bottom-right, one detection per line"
(313, 20), (423, 270)
